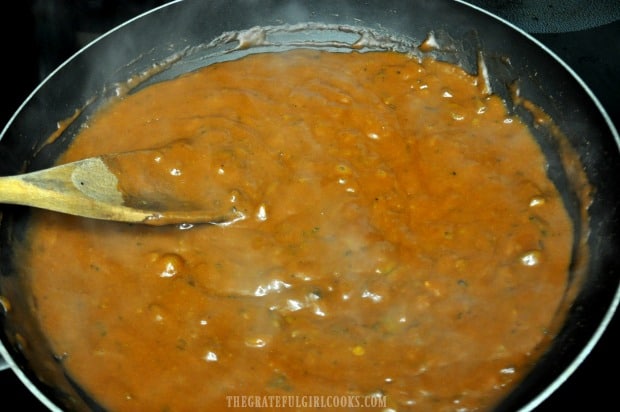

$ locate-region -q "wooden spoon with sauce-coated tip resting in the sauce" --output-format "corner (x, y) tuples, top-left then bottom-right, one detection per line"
(0, 151), (244, 226)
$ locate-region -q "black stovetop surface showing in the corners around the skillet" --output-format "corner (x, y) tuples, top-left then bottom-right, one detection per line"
(0, 0), (620, 412)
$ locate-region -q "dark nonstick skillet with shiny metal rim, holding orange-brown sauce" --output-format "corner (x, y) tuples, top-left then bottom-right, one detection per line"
(0, 0), (620, 410)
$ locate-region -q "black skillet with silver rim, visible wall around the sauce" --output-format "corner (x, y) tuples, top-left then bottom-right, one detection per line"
(0, 1), (620, 410)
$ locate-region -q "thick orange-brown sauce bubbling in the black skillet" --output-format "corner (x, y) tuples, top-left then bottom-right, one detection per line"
(21, 50), (573, 411)
